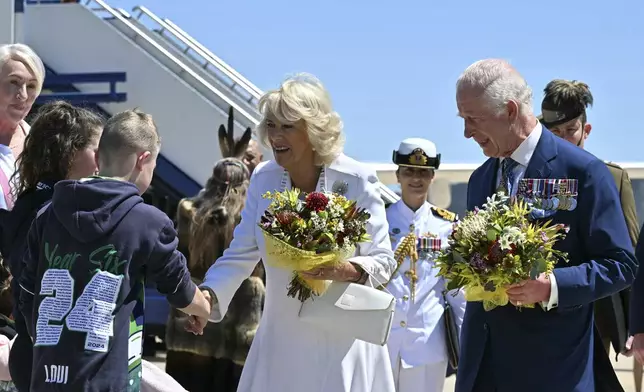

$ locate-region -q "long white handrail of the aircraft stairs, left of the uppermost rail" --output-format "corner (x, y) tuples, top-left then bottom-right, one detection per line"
(80, 0), (257, 124)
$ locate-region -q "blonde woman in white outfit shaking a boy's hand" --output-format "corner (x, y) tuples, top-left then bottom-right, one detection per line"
(197, 75), (395, 392)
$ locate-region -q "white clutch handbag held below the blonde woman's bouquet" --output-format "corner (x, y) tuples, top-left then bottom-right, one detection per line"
(299, 282), (396, 346)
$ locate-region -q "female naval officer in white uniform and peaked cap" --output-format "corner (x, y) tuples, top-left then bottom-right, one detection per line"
(386, 138), (465, 392)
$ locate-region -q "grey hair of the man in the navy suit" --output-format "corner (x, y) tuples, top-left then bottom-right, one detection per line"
(456, 59), (532, 115)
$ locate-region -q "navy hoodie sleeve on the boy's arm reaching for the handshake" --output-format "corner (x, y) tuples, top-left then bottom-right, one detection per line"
(147, 219), (197, 308)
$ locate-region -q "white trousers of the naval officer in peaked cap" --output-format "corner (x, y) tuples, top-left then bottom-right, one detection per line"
(393, 358), (447, 392)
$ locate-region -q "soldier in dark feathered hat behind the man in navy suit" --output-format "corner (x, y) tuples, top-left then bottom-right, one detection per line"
(539, 79), (641, 392)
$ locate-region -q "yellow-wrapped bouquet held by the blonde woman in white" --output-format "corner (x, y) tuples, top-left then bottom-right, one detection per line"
(259, 189), (370, 302)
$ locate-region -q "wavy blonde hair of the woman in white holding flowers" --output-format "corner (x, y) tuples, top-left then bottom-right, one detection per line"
(257, 74), (345, 165)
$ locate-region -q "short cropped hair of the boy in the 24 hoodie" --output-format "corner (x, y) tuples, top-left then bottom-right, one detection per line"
(98, 109), (161, 167)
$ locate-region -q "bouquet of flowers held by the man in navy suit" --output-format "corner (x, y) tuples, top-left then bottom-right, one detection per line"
(436, 193), (568, 310)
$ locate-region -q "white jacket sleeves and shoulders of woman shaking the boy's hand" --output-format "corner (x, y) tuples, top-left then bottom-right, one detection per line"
(203, 154), (395, 321)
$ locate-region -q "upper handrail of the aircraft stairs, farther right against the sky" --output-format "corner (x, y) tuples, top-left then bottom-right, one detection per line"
(132, 6), (261, 105)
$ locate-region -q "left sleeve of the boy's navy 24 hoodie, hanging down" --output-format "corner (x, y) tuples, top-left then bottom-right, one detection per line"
(18, 219), (40, 339)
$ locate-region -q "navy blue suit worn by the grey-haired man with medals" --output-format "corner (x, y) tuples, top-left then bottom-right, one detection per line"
(456, 128), (637, 392)
